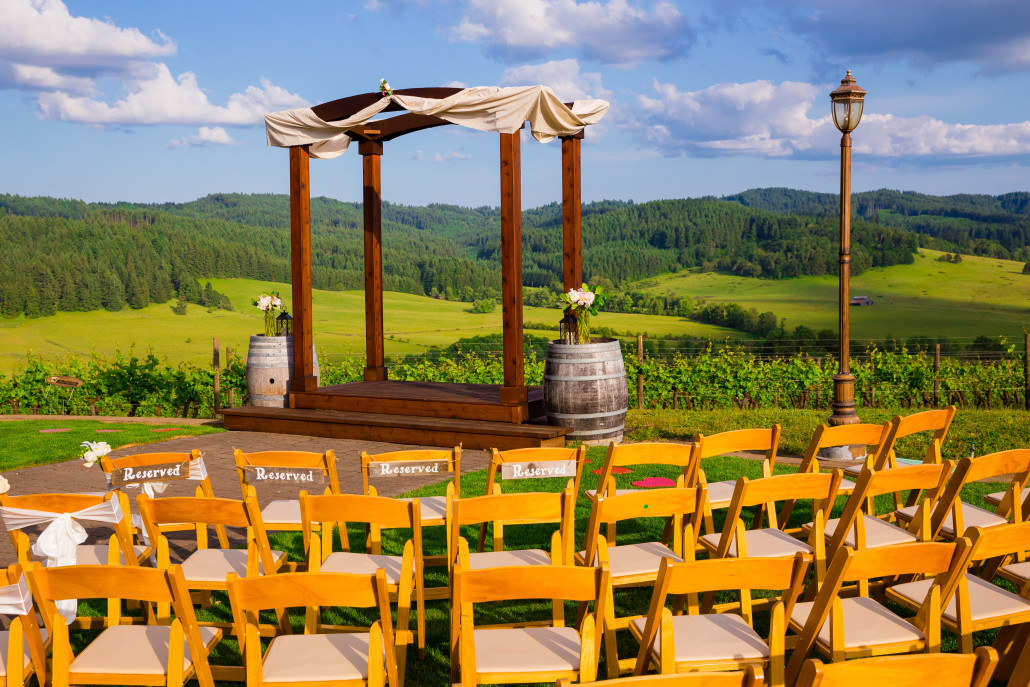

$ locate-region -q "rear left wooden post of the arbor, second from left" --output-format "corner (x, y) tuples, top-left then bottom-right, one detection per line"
(358, 141), (386, 381)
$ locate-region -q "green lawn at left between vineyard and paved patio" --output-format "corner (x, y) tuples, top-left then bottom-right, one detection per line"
(0, 420), (225, 472)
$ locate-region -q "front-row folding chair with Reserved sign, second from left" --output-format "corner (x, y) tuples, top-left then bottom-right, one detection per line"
(233, 448), (340, 531)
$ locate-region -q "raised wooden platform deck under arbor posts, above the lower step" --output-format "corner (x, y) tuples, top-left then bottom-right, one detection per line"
(289, 380), (544, 424)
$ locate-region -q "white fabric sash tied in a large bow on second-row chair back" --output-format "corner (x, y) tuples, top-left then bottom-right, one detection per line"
(0, 499), (122, 623)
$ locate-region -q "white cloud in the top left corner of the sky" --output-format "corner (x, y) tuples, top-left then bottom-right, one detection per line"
(0, 0), (175, 73)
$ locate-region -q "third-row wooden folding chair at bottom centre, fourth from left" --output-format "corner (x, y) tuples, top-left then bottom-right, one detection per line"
(451, 565), (609, 687)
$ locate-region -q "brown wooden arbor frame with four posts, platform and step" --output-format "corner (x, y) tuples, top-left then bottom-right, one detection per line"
(225, 89), (601, 449)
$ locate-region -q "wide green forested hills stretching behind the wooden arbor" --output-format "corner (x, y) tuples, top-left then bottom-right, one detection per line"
(0, 188), (918, 317)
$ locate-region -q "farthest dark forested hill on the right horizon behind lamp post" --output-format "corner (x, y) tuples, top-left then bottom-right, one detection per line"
(723, 188), (1030, 261)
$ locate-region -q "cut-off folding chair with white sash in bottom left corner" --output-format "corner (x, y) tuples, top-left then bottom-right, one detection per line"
(0, 564), (50, 687)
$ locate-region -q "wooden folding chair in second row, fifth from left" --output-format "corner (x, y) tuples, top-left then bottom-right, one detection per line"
(577, 484), (707, 678)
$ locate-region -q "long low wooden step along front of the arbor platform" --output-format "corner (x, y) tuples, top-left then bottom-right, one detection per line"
(222, 406), (568, 450)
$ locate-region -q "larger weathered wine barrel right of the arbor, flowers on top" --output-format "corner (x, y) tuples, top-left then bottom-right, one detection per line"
(544, 338), (629, 444)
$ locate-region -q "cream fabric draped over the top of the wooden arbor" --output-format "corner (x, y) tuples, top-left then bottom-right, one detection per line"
(265, 85), (608, 160)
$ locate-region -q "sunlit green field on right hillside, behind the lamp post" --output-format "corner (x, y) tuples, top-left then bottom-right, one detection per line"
(642, 249), (1030, 340)
